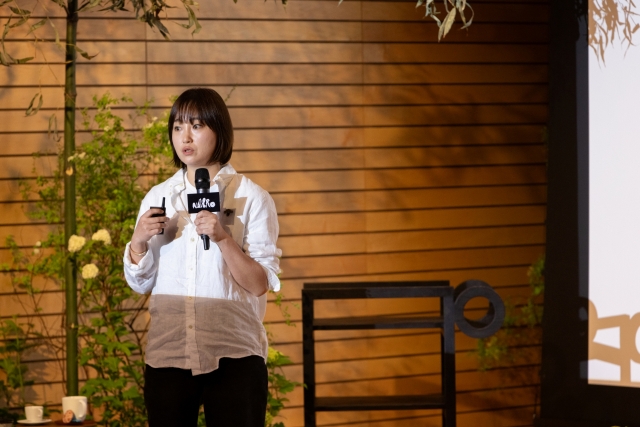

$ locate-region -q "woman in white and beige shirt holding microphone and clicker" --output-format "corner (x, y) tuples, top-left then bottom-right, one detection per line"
(124, 88), (281, 427)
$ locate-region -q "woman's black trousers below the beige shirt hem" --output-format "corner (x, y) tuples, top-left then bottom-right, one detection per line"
(144, 356), (268, 427)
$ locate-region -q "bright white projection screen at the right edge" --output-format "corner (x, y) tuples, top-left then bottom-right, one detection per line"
(588, 0), (640, 387)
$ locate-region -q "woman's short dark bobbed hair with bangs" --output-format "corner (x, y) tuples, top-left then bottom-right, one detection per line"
(169, 87), (233, 169)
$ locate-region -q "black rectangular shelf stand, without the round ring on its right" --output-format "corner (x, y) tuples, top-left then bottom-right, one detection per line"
(302, 281), (456, 427)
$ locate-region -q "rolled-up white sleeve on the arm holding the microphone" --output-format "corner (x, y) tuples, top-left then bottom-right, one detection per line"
(242, 190), (282, 292)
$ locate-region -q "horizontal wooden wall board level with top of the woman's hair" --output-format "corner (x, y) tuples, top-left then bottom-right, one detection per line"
(0, 84), (547, 109)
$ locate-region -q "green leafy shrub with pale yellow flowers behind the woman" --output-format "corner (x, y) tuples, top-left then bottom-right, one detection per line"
(4, 94), (297, 427)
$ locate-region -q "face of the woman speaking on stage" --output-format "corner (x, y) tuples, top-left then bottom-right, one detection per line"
(171, 120), (218, 169)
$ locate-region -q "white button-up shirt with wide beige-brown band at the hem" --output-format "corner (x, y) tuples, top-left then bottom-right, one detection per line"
(124, 164), (281, 375)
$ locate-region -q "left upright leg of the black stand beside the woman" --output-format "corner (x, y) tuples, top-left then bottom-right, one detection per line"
(302, 289), (316, 427)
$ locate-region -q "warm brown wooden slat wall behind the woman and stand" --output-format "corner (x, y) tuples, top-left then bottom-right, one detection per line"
(0, 0), (548, 427)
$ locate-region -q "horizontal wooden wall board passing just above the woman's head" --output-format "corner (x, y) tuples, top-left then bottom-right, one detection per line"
(0, 63), (547, 86)
